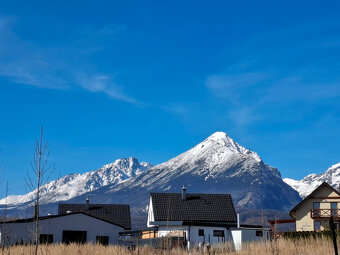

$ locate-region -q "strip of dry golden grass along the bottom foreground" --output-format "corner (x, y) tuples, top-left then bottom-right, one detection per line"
(0, 238), (339, 255)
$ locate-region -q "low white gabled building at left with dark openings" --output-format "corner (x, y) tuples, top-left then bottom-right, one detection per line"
(0, 212), (124, 245)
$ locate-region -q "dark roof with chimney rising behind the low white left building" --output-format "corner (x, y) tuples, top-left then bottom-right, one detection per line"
(58, 204), (131, 230)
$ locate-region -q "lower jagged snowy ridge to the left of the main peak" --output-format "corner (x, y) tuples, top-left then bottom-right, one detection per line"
(0, 157), (152, 207)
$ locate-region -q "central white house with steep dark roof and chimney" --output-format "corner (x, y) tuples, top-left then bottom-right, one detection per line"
(147, 187), (269, 249)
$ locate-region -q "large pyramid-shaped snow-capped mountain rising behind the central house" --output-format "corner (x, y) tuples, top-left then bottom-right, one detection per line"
(68, 132), (300, 210)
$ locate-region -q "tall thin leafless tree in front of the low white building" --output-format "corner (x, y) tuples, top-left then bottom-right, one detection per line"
(26, 127), (55, 255)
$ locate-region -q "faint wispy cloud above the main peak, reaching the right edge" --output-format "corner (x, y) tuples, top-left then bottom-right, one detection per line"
(205, 57), (340, 126)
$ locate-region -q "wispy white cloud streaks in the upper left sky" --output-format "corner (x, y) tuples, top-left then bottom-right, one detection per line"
(0, 17), (142, 106)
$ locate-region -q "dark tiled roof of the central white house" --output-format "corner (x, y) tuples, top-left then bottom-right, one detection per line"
(151, 193), (236, 224)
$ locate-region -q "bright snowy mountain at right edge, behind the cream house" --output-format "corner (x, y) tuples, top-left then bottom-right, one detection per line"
(283, 163), (340, 198)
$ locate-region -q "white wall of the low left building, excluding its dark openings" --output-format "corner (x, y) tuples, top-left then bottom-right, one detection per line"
(0, 213), (124, 244)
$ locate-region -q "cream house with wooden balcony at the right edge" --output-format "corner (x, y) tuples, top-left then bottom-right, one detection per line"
(289, 182), (340, 231)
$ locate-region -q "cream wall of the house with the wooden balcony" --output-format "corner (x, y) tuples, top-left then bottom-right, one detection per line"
(296, 187), (340, 231)
